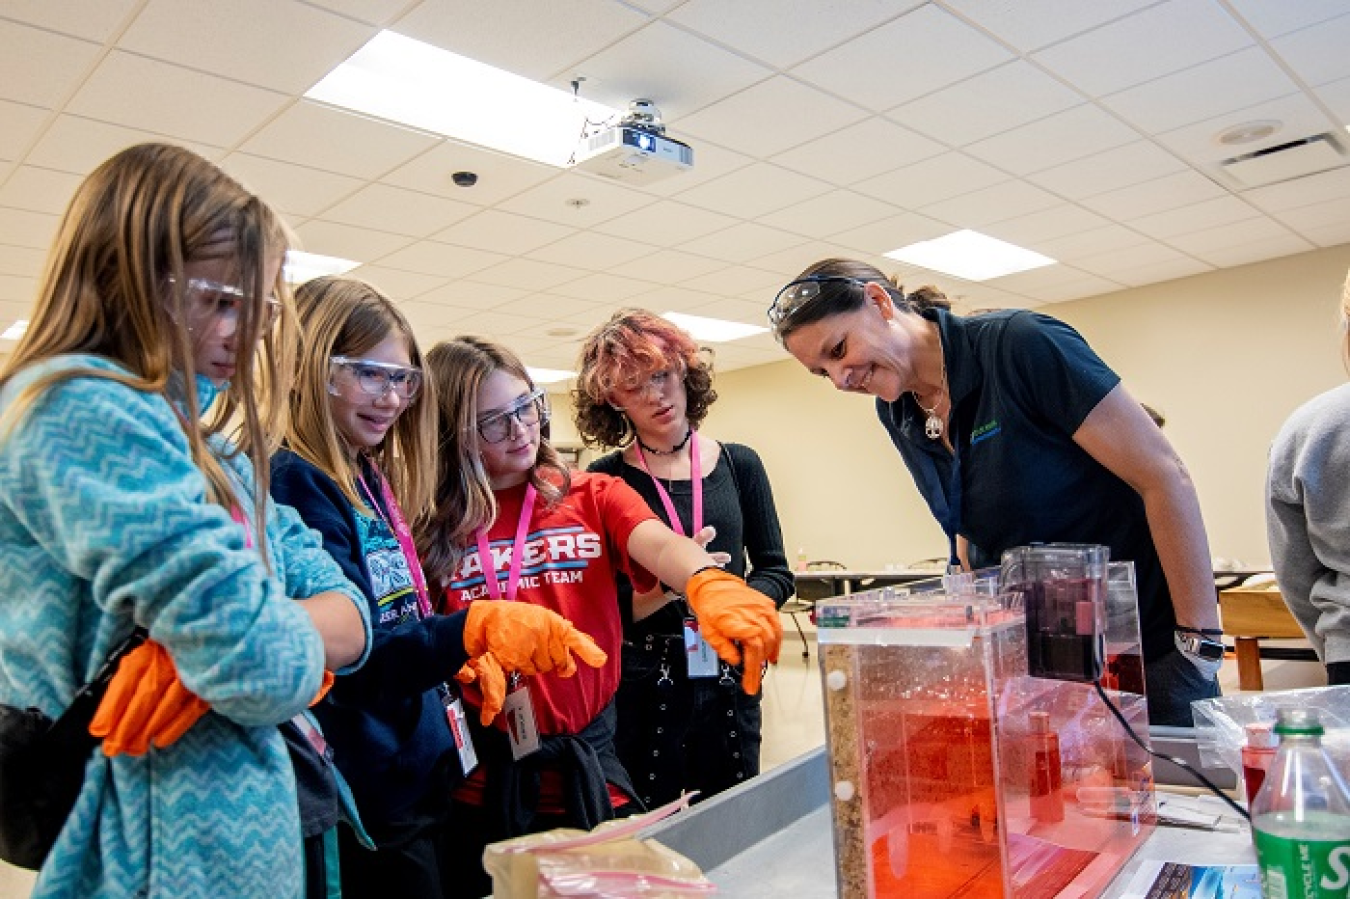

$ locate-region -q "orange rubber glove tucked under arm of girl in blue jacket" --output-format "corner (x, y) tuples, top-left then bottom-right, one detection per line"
(89, 640), (211, 759)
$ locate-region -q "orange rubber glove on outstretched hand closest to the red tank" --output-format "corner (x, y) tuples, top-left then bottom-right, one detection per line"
(684, 568), (783, 695)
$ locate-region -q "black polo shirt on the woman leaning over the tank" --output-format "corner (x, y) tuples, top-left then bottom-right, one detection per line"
(876, 309), (1176, 661)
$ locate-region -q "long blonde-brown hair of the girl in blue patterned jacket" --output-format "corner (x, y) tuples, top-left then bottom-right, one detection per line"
(0, 143), (296, 560)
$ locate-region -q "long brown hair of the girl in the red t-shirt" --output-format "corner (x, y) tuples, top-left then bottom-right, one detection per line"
(417, 337), (571, 584)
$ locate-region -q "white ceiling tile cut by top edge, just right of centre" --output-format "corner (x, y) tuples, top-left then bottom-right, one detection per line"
(670, 0), (921, 69)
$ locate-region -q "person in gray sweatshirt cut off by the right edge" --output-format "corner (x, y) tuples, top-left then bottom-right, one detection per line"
(1266, 269), (1350, 684)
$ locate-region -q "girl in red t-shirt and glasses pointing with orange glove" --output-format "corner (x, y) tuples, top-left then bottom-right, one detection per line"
(417, 337), (783, 895)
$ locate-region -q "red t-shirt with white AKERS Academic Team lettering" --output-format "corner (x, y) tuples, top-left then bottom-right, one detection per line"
(446, 472), (656, 736)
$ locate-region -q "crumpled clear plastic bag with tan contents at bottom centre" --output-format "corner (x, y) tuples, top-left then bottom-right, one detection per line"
(483, 796), (717, 899)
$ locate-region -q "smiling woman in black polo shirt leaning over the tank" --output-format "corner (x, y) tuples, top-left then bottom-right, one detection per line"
(768, 259), (1220, 726)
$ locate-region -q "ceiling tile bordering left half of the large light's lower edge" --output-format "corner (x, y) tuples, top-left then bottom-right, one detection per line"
(240, 100), (439, 178)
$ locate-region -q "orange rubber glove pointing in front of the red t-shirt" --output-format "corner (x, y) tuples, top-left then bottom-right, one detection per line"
(464, 599), (609, 678)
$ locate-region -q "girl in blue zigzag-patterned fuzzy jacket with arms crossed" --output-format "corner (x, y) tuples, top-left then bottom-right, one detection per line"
(0, 144), (370, 899)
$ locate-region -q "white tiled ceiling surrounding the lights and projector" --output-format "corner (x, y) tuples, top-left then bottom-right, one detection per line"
(0, 0), (1350, 370)
